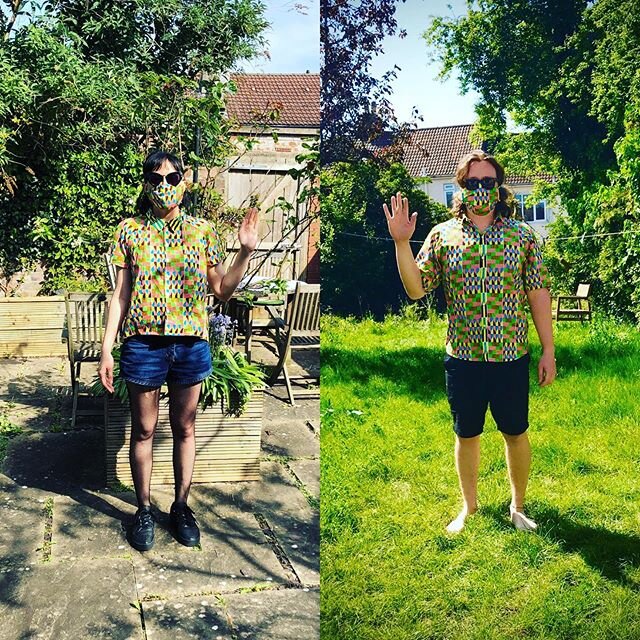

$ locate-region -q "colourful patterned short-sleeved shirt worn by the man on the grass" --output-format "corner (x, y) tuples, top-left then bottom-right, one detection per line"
(416, 215), (550, 362)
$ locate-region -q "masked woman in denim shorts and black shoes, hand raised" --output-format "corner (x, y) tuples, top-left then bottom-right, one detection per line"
(100, 151), (258, 551)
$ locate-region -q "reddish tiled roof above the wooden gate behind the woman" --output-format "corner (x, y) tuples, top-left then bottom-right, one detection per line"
(227, 73), (320, 128)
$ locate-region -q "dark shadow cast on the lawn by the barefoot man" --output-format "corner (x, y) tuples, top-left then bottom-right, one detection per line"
(482, 503), (640, 591)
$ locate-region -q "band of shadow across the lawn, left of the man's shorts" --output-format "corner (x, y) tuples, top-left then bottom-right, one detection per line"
(320, 347), (445, 402)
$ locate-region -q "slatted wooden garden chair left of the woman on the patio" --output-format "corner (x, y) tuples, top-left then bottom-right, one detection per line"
(64, 291), (111, 428)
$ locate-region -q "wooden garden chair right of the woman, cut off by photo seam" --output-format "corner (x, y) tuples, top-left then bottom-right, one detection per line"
(268, 282), (320, 405)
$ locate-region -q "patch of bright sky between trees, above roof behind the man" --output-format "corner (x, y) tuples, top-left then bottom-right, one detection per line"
(373, 0), (478, 127)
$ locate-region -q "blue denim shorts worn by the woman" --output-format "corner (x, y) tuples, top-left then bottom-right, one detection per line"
(120, 335), (213, 387)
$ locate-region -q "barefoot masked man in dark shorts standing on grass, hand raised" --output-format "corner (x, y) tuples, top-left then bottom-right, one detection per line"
(384, 151), (556, 533)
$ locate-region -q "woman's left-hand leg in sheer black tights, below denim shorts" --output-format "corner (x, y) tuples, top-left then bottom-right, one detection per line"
(127, 382), (160, 507)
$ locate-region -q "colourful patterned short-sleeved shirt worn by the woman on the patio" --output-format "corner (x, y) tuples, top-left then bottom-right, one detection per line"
(106, 213), (225, 339)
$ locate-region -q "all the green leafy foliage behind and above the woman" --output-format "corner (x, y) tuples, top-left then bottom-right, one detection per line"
(0, 0), (266, 292)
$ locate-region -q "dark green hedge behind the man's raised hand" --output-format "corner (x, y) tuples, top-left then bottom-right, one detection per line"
(320, 160), (448, 317)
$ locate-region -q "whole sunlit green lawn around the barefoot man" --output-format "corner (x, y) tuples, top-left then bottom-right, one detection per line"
(321, 316), (640, 640)
